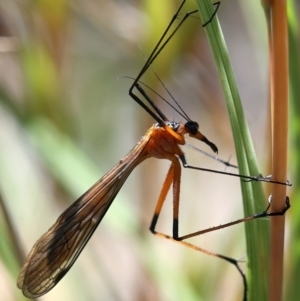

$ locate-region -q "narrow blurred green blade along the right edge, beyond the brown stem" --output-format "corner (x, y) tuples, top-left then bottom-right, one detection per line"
(284, 1), (300, 301)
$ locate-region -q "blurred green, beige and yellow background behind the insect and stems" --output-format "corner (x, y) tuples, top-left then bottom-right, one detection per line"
(0, 0), (300, 301)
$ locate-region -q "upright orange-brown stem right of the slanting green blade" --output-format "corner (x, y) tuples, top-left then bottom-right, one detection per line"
(262, 0), (288, 301)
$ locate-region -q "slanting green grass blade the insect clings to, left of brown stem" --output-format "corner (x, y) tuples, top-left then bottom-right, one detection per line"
(196, 0), (269, 301)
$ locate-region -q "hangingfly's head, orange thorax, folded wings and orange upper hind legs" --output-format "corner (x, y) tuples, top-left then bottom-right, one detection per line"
(17, 122), (216, 298)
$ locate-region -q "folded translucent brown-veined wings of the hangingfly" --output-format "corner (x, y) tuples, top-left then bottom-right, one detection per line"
(17, 135), (150, 298)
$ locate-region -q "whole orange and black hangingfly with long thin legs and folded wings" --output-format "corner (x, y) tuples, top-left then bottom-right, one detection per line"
(17, 1), (289, 300)
